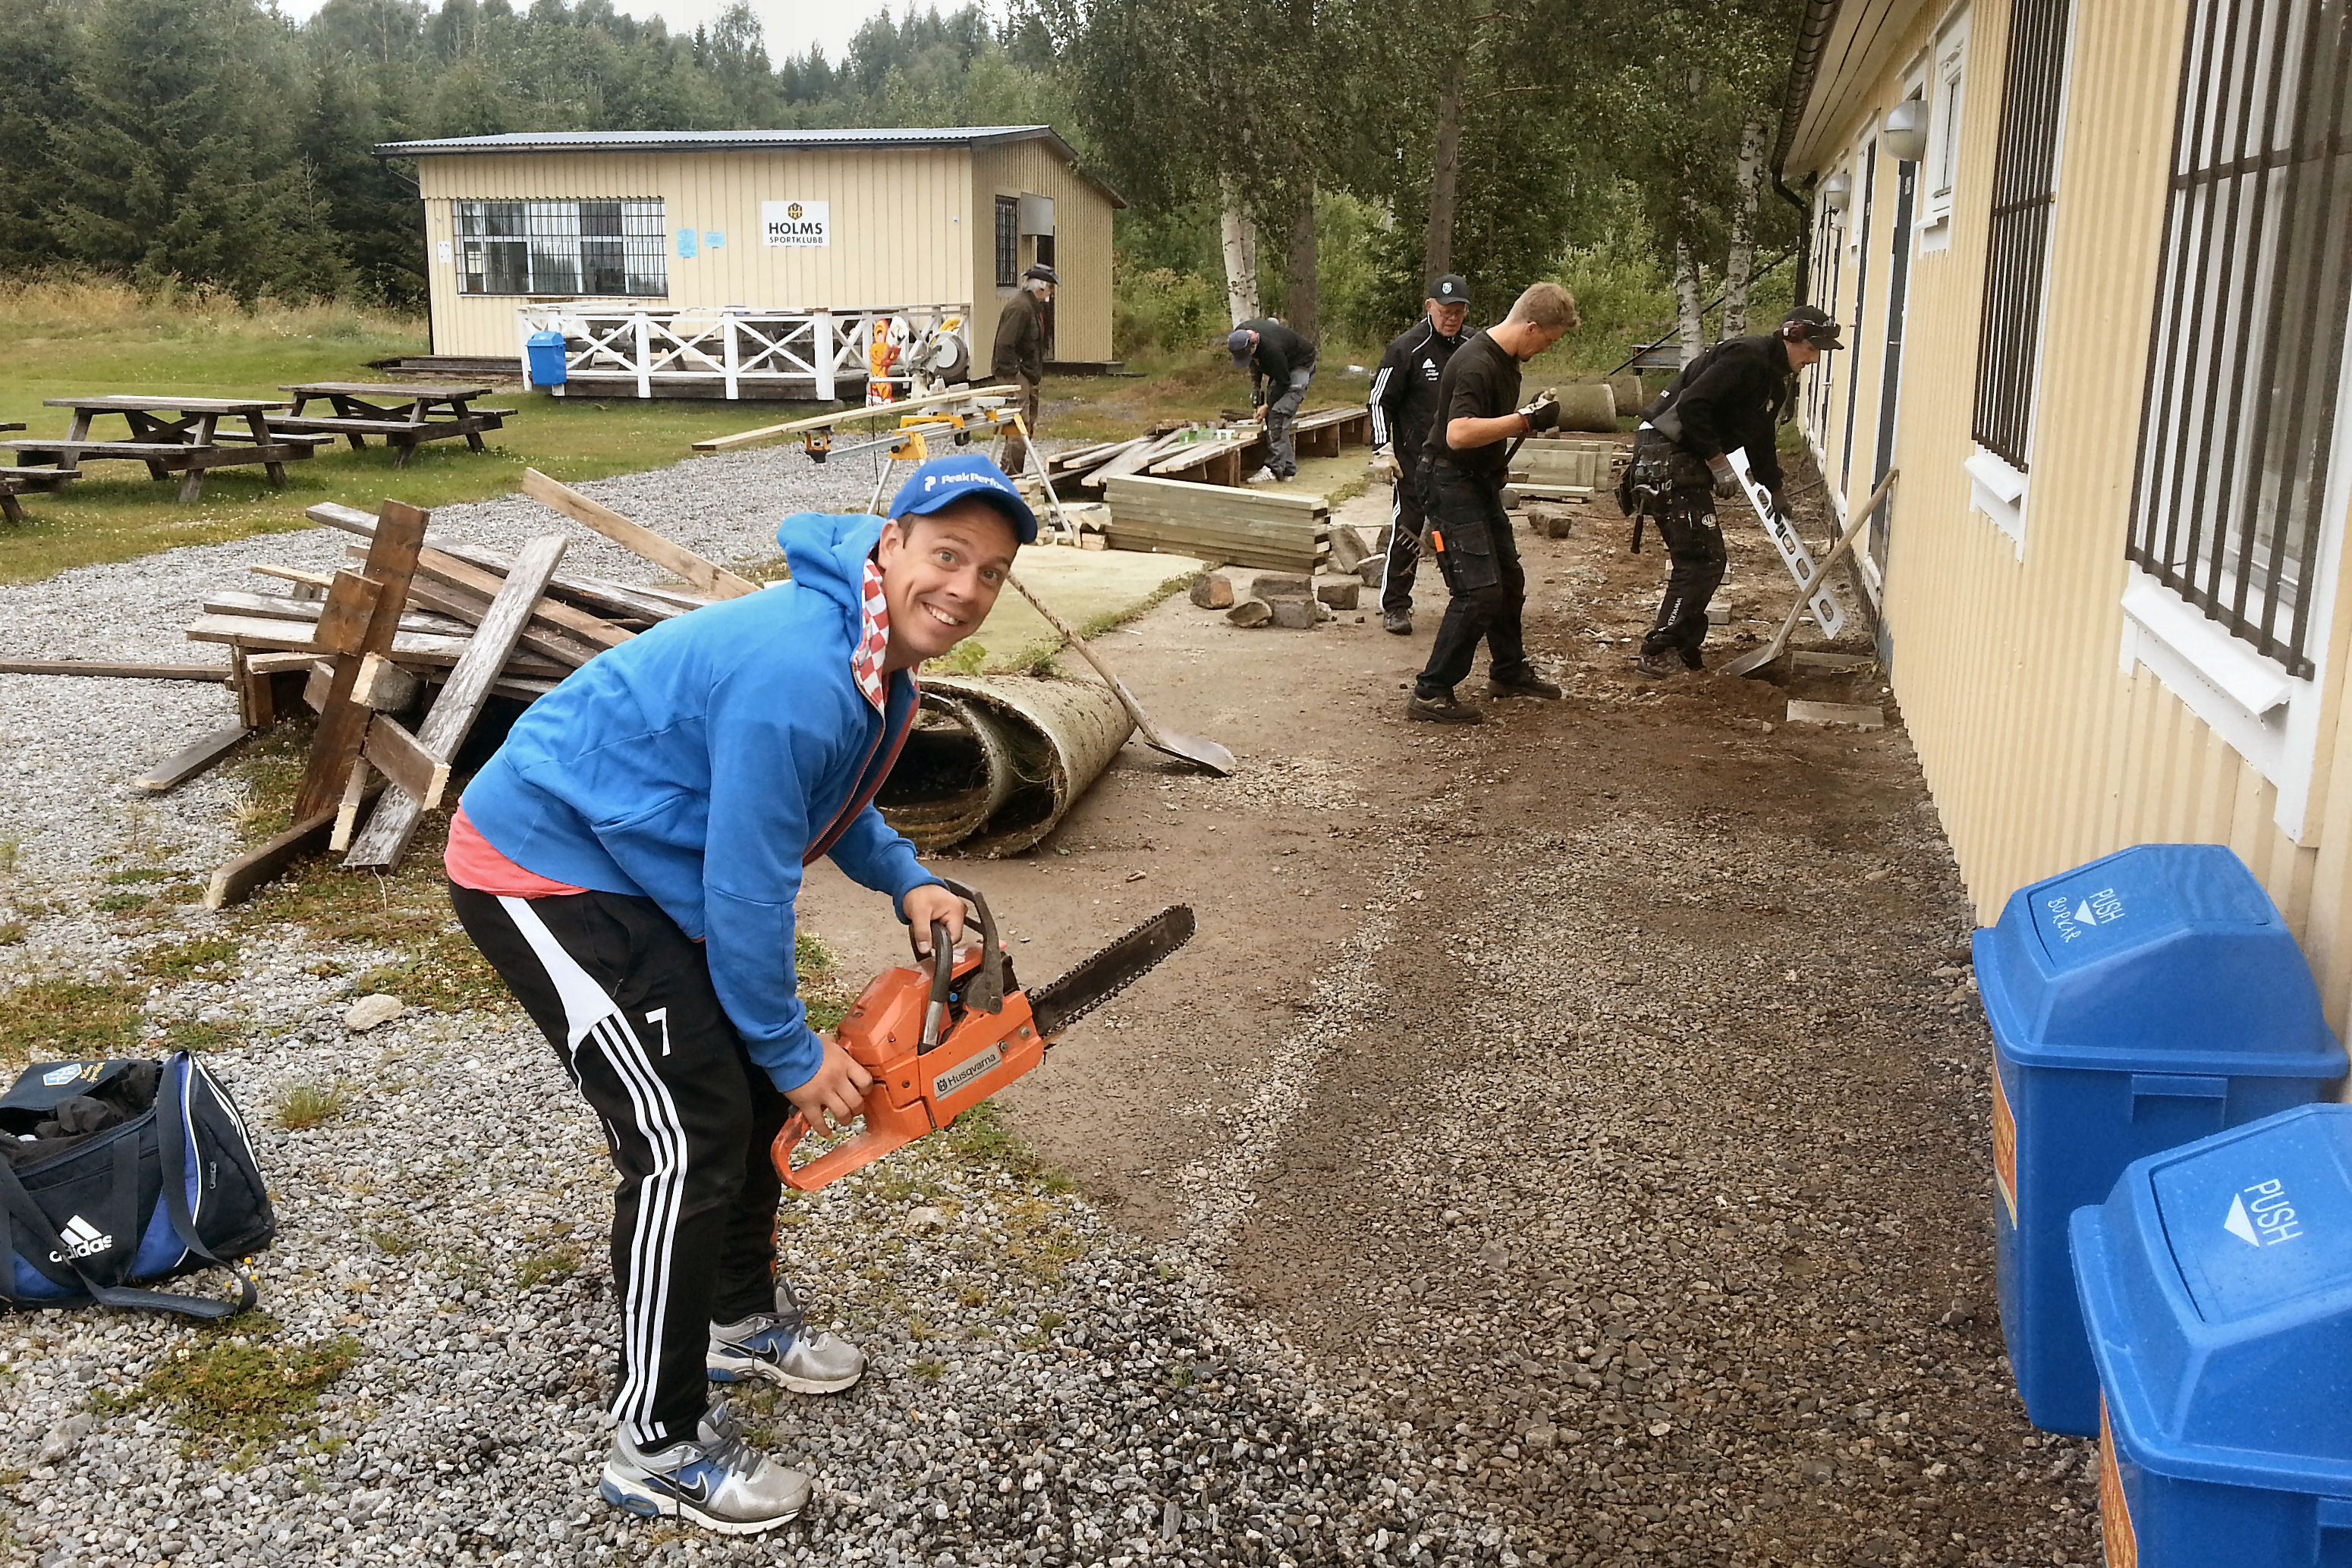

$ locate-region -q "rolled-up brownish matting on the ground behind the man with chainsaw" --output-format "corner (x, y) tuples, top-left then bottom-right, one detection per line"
(877, 674), (1134, 860)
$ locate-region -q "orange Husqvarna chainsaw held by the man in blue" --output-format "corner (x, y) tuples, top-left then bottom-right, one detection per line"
(772, 879), (1193, 1192)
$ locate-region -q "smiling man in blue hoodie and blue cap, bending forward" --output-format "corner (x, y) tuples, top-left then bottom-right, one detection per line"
(447, 454), (1037, 1535)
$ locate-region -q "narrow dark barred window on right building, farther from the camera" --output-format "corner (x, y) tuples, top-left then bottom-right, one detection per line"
(1971, 0), (2074, 473)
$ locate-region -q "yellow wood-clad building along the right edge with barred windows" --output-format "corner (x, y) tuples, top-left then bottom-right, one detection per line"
(1773, 0), (2352, 1029)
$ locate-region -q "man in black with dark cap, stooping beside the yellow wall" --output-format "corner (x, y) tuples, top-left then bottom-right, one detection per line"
(1618, 306), (1844, 677)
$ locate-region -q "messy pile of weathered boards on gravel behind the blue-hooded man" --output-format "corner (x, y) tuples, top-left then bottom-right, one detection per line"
(176, 470), (757, 907)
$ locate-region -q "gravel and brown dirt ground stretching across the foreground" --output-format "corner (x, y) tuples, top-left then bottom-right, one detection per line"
(0, 441), (2096, 1568)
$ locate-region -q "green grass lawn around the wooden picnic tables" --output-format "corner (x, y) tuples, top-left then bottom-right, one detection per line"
(0, 287), (818, 583)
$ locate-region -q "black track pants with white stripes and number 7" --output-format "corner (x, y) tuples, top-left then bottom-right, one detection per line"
(449, 886), (793, 1448)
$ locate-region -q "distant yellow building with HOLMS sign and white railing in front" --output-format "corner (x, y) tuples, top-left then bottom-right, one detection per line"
(376, 124), (1124, 397)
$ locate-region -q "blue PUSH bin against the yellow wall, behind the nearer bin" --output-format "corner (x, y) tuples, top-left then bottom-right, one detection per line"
(1976, 844), (2345, 1436)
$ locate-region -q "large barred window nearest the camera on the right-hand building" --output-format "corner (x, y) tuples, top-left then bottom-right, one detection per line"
(2126, 0), (2352, 677)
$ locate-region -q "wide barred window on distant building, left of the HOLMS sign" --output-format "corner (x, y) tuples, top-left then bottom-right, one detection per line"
(456, 200), (671, 299)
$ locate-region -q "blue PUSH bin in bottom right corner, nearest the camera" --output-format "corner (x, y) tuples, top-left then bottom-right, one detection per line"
(2072, 1105), (2352, 1568)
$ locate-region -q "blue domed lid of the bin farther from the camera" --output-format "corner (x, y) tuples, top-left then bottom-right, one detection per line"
(1976, 844), (2345, 1079)
